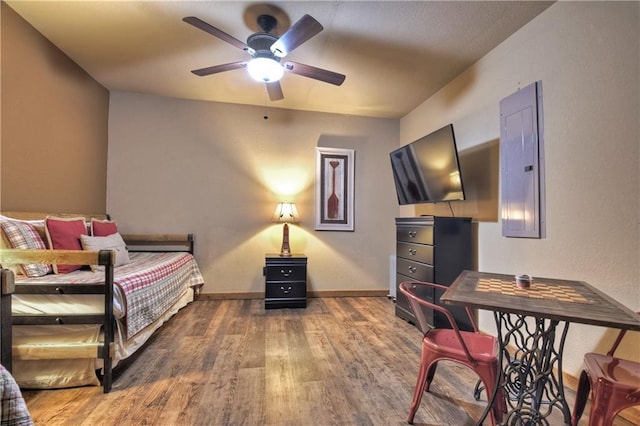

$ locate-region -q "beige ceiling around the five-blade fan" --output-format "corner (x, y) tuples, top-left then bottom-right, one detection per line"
(7, 0), (551, 118)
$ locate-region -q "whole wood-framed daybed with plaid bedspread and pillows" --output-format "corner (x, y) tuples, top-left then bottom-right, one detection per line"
(0, 213), (204, 392)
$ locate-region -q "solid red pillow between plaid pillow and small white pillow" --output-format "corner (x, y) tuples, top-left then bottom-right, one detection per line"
(44, 216), (87, 274)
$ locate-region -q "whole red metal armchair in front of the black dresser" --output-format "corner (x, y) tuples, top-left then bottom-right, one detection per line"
(399, 281), (506, 425)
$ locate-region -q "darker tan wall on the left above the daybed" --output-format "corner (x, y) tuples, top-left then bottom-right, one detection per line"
(0, 2), (109, 213)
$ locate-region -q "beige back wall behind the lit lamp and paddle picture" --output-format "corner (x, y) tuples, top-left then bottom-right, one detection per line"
(107, 88), (399, 293)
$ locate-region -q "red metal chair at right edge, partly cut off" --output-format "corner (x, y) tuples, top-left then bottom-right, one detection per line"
(571, 322), (640, 426)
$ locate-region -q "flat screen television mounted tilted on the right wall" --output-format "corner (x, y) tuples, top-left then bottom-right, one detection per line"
(389, 124), (464, 205)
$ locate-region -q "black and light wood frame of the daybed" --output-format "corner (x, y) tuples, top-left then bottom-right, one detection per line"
(0, 212), (196, 393)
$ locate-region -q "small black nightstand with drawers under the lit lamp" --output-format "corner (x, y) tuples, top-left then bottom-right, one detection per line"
(263, 254), (307, 309)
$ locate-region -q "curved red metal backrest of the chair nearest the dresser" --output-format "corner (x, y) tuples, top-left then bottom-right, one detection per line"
(399, 281), (477, 362)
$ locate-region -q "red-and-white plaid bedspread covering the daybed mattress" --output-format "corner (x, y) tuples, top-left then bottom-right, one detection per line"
(14, 252), (204, 339)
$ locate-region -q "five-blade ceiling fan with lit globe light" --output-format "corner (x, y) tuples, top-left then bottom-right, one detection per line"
(183, 6), (345, 101)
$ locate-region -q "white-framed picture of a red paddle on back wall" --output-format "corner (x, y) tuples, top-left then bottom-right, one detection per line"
(315, 147), (355, 231)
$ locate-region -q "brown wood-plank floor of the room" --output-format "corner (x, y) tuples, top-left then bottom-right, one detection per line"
(24, 297), (630, 426)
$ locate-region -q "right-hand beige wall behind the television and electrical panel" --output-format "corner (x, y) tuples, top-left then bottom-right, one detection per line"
(400, 2), (640, 375)
